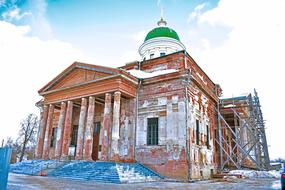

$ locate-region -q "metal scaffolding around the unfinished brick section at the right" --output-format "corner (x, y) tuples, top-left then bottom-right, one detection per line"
(215, 90), (270, 171)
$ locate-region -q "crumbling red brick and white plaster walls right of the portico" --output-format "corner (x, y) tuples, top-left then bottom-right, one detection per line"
(128, 52), (218, 180)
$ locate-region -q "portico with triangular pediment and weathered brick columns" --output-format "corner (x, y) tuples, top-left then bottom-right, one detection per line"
(36, 63), (137, 161)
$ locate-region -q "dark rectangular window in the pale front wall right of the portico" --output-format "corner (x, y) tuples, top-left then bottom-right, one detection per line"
(147, 118), (158, 145)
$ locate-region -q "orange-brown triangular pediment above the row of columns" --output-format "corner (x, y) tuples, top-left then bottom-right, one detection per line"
(39, 62), (118, 93)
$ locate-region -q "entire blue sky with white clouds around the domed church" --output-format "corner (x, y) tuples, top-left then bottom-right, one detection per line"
(0, 0), (285, 158)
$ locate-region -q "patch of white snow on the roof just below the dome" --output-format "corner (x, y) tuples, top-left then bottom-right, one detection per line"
(127, 69), (178, 79)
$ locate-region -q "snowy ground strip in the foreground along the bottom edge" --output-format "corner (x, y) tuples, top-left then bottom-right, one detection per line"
(8, 173), (281, 190)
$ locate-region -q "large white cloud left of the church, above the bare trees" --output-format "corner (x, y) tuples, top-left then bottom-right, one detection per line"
(0, 21), (92, 140)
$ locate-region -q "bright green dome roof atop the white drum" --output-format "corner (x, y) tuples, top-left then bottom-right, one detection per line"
(144, 27), (180, 41)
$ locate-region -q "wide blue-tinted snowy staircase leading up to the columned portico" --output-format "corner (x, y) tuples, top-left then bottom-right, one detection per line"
(11, 160), (163, 183)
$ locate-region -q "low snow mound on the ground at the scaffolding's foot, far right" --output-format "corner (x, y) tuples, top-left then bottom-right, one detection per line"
(229, 170), (280, 178)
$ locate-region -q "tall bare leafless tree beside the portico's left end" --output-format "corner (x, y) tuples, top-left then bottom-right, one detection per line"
(16, 114), (39, 162)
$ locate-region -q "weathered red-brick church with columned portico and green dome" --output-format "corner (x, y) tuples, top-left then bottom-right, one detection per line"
(35, 18), (222, 181)
